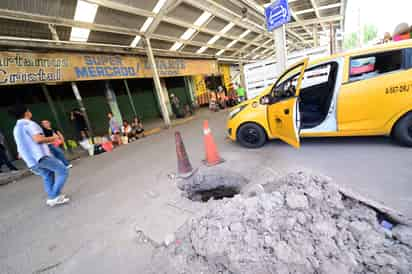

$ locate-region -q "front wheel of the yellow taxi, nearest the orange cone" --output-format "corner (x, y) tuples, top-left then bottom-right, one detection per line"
(236, 123), (266, 148)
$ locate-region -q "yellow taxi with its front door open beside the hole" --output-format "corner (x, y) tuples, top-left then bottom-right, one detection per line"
(227, 40), (412, 148)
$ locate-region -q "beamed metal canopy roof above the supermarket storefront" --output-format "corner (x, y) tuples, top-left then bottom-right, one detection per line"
(0, 0), (347, 61)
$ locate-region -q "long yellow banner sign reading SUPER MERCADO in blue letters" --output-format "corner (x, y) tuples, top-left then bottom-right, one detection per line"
(0, 52), (219, 85)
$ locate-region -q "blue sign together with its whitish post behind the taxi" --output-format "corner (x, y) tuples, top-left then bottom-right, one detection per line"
(265, 0), (291, 71)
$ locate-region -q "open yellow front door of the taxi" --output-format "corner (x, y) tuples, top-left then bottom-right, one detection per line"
(267, 58), (308, 148)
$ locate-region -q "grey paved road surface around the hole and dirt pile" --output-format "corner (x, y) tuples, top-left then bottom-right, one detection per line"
(0, 108), (412, 274)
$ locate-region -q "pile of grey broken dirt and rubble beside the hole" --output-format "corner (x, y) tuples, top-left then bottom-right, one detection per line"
(149, 172), (412, 274)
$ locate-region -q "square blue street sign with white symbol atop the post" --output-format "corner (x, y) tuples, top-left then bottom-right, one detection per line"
(265, 0), (290, 31)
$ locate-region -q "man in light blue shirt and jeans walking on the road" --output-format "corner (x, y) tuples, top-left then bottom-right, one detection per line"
(13, 105), (70, 207)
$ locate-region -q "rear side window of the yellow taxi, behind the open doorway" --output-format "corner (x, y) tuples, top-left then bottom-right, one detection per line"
(349, 50), (402, 81)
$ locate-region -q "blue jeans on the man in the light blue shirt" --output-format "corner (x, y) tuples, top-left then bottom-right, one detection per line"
(31, 156), (69, 199)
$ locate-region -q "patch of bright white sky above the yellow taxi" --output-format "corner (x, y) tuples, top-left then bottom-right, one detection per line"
(345, 0), (412, 37)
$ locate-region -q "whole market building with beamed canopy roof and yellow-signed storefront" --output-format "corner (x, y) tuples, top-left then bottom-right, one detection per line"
(0, 0), (345, 154)
